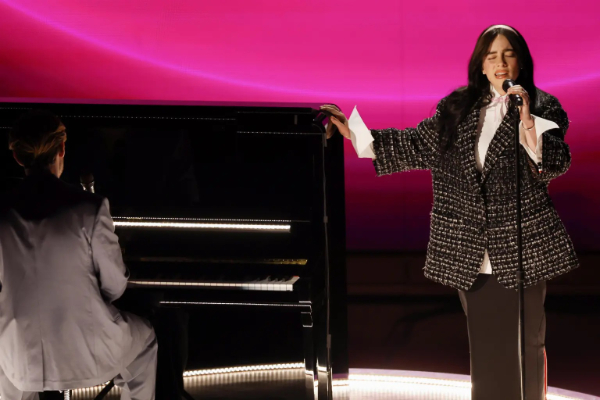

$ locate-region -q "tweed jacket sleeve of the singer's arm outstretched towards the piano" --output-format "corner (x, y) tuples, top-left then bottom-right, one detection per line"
(371, 99), (444, 176)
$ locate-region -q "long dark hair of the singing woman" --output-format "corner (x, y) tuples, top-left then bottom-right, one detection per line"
(438, 25), (537, 152)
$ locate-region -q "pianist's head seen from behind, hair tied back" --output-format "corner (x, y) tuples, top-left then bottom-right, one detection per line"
(8, 110), (67, 177)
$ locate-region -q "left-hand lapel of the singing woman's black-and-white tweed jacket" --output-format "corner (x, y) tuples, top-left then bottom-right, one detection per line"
(456, 107), (481, 193)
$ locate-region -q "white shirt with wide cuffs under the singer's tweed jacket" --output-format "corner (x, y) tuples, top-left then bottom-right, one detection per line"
(348, 86), (558, 274)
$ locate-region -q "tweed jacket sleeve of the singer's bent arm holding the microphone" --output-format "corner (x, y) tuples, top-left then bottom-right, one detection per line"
(528, 96), (571, 182)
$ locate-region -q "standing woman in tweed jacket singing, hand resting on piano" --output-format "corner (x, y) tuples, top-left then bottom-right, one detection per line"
(321, 25), (578, 400)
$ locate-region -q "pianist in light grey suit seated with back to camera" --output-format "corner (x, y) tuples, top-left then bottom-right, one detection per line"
(0, 110), (157, 400)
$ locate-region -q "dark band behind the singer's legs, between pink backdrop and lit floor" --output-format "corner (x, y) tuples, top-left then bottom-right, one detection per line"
(347, 253), (600, 396)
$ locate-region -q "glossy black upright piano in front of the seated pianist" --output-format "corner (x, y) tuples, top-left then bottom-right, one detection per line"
(0, 98), (348, 399)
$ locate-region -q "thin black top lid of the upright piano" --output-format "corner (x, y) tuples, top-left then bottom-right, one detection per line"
(0, 97), (333, 113)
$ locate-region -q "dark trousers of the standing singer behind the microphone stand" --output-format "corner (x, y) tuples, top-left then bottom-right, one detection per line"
(459, 274), (546, 400)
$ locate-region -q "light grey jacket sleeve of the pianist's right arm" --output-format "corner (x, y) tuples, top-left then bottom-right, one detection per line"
(91, 199), (128, 302)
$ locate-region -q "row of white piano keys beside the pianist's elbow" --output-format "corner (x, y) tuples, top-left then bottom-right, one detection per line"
(128, 276), (300, 292)
